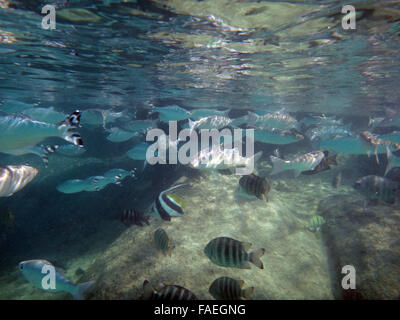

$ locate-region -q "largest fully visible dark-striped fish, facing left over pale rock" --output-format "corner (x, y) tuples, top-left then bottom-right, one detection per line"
(204, 237), (265, 269)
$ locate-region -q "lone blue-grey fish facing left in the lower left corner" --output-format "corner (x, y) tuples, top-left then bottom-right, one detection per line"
(18, 259), (94, 300)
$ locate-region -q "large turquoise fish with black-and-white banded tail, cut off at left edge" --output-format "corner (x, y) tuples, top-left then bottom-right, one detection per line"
(0, 110), (83, 154)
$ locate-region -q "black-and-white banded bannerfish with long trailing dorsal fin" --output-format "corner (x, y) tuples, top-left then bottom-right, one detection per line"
(153, 184), (185, 221)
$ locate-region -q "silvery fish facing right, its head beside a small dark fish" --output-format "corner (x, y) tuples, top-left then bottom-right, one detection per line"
(270, 151), (325, 177)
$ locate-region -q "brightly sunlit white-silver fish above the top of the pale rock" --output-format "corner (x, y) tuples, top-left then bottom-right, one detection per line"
(189, 146), (262, 174)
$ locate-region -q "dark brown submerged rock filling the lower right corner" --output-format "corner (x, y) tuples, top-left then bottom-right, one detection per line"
(317, 195), (400, 300)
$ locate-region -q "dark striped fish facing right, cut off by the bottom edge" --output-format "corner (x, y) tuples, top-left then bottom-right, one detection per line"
(140, 280), (197, 301)
